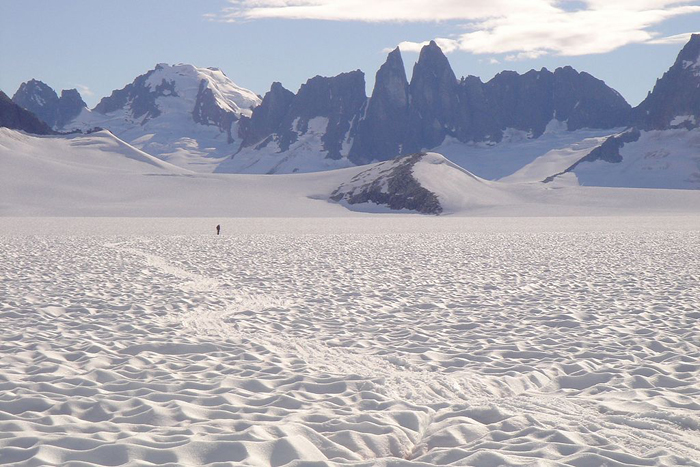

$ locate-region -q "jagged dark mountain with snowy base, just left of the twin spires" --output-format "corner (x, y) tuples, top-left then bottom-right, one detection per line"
(218, 70), (367, 174)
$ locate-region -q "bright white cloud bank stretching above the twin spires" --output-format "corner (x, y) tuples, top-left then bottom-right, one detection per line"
(217, 0), (700, 60)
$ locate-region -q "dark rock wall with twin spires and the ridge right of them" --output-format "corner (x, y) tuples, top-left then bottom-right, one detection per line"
(350, 42), (630, 163)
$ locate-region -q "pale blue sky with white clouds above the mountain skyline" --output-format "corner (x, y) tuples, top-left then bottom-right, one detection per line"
(0, 0), (700, 107)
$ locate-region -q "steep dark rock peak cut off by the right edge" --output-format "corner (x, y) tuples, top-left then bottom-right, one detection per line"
(634, 34), (700, 130)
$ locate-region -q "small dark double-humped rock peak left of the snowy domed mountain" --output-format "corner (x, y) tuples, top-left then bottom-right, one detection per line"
(12, 79), (87, 128)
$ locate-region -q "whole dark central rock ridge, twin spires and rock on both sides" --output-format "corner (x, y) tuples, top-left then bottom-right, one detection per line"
(240, 42), (631, 164)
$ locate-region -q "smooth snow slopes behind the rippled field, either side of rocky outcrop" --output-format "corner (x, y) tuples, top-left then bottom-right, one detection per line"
(0, 128), (700, 217)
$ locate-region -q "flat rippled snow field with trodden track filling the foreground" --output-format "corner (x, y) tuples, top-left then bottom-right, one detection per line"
(0, 215), (700, 467)
